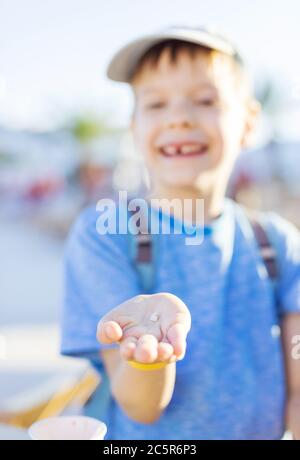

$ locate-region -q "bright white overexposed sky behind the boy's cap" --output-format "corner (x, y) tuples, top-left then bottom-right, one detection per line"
(0, 0), (300, 138)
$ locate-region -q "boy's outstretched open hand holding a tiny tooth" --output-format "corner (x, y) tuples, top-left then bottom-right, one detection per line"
(97, 292), (191, 363)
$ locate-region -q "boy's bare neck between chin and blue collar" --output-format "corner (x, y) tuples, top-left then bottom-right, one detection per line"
(146, 186), (224, 224)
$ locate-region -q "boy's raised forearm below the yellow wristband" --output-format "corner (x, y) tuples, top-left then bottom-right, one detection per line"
(101, 350), (176, 423)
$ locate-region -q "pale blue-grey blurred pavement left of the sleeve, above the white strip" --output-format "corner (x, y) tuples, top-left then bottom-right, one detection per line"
(0, 219), (63, 328)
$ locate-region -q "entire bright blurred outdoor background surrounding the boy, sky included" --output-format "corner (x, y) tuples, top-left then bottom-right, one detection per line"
(0, 0), (300, 438)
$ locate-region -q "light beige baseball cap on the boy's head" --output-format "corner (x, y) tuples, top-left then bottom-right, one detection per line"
(106, 26), (243, 83)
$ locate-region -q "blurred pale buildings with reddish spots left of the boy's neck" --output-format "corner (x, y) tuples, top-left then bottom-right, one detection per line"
(0, 128), (133, 237)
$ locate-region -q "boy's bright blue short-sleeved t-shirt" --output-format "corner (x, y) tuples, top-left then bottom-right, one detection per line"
(61, 200), (300, 440)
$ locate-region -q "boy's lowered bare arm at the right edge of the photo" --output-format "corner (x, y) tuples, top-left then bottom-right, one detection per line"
(282, 313), (300, 397)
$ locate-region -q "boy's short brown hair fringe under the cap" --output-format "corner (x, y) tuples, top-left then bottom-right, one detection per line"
(130, 39), (252, 98)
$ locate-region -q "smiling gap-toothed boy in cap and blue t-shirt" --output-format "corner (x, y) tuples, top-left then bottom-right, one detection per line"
(62, 27), (300, 439)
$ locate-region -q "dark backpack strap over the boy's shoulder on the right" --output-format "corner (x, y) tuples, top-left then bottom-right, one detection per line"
(247, 211), (279, 282)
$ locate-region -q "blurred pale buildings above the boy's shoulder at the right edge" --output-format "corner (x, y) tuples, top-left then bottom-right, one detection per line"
(229, 141), (300, 228)
